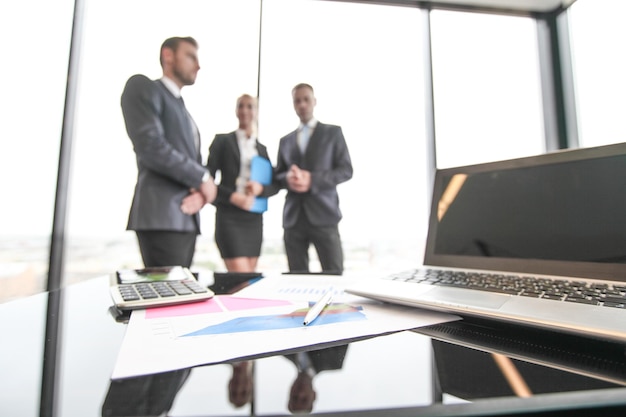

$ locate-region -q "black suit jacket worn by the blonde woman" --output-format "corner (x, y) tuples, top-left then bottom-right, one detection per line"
(207, 132), (269, 210)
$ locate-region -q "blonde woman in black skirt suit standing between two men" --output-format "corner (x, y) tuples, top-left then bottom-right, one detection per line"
(208, 94), (269, 272)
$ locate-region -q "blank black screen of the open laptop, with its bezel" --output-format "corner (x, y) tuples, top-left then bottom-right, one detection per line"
(425, 144), (626, 281)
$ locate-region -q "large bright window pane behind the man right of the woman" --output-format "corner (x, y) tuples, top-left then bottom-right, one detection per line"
(259, 0), (429, 270)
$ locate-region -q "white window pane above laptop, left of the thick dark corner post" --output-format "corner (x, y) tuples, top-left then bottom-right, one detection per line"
(431, 10), (545, 168)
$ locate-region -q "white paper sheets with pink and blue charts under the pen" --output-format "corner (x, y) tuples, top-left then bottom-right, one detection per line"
(111, 275), (459, 379)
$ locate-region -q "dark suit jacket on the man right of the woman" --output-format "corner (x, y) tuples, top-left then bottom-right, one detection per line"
(274, 122), (352, 228)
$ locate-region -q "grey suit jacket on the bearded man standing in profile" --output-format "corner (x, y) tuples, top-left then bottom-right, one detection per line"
(121, 75), (206, 233)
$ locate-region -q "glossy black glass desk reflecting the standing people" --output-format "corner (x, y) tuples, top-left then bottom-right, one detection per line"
(0, 277), (626, 417)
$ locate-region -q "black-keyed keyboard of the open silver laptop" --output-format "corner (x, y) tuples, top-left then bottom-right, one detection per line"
(387, 268), (626, 308)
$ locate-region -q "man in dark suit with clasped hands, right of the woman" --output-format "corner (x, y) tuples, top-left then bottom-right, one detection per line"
(275, 84), (352, 274)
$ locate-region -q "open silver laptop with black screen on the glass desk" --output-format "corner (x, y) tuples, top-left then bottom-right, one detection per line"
(346, 143), (626, 342)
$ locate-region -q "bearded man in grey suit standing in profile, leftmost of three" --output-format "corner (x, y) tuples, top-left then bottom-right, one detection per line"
(121, 37), (217, 267)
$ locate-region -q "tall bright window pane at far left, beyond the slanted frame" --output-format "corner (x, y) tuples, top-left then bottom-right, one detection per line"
(0, 0), (74, 302)
